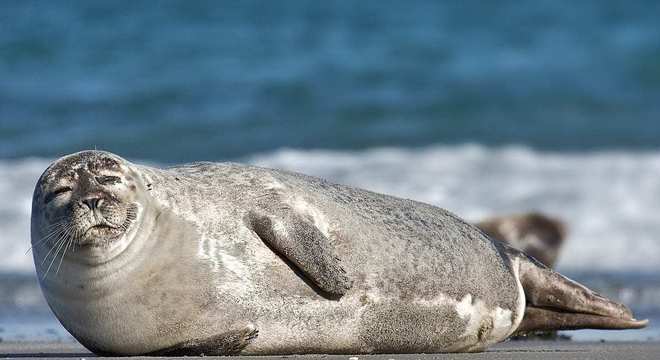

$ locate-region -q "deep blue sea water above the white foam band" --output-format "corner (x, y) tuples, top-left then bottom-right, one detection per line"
(0, 0), (660, 162)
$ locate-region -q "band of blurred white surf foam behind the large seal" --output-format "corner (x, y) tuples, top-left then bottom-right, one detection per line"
(0, 145), (660, 272)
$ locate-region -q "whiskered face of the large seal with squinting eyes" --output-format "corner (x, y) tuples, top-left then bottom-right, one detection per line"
(34, 151), (138, 248)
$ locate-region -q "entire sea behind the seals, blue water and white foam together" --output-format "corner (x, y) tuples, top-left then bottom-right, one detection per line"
(0, 0), (660, 340)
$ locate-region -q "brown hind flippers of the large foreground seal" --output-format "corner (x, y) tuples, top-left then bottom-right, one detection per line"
(517, 254), (648, 332)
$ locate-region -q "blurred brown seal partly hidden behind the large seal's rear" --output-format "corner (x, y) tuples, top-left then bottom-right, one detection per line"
(475, 212), (566, 268)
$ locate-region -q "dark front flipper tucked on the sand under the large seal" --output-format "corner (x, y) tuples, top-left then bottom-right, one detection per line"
(147, 326), (259, 356)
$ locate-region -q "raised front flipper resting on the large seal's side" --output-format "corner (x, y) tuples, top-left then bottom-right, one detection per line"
(246, 210), (351, 296)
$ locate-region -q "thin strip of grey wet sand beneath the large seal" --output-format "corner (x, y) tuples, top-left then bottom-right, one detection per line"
(0, 341), (660, 360)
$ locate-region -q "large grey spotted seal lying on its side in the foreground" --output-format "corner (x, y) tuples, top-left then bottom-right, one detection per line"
(31, 151), (646, 355)
